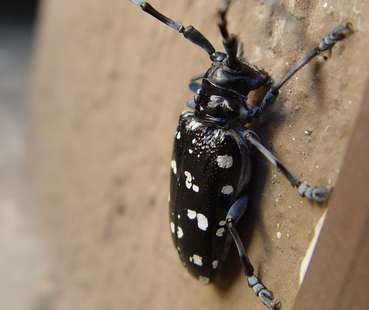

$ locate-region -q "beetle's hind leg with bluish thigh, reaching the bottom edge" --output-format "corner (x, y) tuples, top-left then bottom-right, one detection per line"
(226, 196), (280, 310)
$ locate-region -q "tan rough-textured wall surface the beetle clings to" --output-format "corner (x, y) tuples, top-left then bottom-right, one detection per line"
(31, 0), (369, 310)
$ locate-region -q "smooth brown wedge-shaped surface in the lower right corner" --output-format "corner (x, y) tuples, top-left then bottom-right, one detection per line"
(293, 84), (369, 310)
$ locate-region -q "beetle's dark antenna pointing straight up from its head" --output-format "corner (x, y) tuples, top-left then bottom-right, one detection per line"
(218, 0), (239, 67)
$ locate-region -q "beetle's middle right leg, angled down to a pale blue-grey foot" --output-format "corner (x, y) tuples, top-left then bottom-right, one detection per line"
(241, 130), (332, 203)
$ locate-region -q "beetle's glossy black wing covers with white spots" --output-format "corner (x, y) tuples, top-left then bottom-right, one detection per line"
(169, 112), (250, 283)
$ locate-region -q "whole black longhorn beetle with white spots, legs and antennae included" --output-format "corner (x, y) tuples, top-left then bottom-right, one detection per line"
(131, 0), (353, 309)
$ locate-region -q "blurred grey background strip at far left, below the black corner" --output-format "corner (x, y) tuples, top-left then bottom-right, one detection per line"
(0, 22), (51, 310)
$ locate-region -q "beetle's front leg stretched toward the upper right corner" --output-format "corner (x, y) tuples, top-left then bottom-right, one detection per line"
(252, 23), (353, 117)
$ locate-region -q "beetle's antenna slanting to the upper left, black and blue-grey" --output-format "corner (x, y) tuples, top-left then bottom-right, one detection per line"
(131, 0), (215, 56)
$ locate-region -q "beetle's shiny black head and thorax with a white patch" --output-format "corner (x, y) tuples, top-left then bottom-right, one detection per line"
(196, 59), (267, 126)
